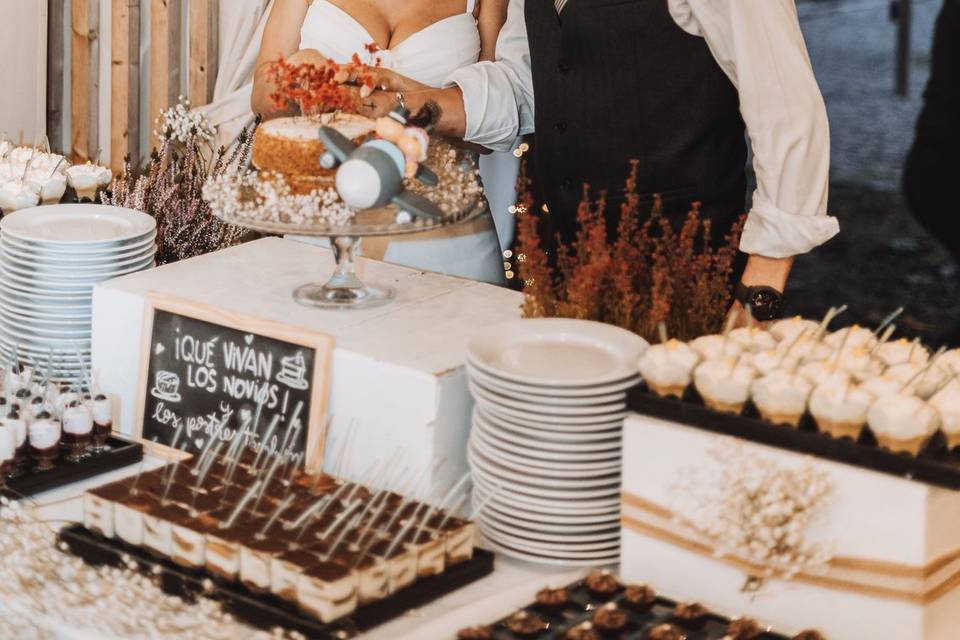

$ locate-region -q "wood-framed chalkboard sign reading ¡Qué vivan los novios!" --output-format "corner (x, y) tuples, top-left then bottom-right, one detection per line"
(133, 294), (333, 469)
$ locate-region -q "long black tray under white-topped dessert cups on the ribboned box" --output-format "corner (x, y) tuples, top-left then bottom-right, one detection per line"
(627, 386), (960, 490)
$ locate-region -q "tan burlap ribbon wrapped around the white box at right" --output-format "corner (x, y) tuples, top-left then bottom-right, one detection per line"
(621, 493), (960, 605)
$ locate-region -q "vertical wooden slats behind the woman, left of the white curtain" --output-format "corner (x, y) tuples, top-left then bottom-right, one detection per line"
(56, 0), (220, 171)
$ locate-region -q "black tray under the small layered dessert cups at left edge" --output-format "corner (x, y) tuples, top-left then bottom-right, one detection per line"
(0, 436), (143, 498)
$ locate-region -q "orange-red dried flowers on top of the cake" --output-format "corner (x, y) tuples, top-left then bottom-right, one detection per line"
(267, 52), (375, 115)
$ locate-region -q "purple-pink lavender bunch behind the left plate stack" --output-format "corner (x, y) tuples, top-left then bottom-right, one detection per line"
(101, 110), (260, 264)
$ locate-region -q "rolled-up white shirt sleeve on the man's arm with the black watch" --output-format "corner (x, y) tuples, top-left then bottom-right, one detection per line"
(670, 0), (840, 258)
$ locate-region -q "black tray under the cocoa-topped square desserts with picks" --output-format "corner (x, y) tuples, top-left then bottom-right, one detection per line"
(59, 525), (494, 640)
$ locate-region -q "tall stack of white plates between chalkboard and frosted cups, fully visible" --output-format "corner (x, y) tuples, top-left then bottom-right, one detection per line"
(467, 319), (648, 565)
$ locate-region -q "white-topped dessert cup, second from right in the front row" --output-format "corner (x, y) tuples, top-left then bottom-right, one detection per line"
(867, 393), (940, 455)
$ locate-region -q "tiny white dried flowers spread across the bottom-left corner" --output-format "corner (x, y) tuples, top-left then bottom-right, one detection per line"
(0, 498), (303, 640)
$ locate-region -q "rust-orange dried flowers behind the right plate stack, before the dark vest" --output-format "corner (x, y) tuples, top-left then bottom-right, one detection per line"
(517, 163), (744, 342)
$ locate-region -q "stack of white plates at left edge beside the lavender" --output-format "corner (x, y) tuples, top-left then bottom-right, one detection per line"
(0, 204), (157, 379)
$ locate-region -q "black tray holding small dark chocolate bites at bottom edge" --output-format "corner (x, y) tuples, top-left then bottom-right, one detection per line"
(490, 580), (788, 640)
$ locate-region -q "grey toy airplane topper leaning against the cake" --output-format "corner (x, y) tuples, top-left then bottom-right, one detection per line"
(320, 109), (444, 220)
